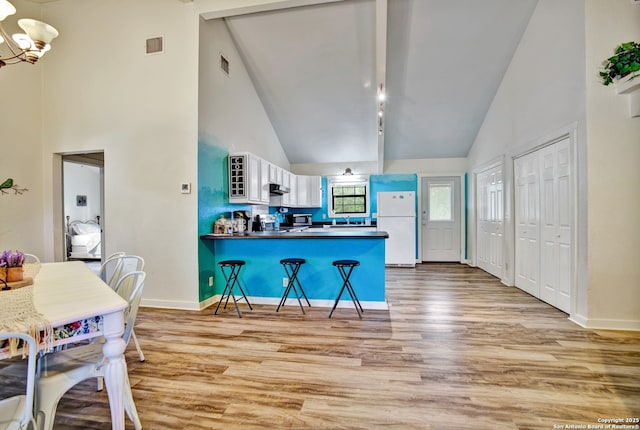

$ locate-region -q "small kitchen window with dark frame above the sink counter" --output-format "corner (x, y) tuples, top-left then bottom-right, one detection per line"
(328, 176), (369, 218)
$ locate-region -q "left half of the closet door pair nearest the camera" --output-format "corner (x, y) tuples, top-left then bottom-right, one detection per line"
(514, 153), (540, 297)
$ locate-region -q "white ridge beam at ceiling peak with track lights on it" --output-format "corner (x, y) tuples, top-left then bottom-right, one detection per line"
(376, 0), (387, 175)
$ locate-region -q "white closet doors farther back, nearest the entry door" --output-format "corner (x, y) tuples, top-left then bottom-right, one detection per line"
(476, 164), (504, 278)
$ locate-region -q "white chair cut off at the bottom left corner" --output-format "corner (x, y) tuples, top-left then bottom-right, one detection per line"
(0, 333), (37, 430)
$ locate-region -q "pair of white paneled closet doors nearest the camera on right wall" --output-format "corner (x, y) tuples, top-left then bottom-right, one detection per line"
(514, 138), (573, 312)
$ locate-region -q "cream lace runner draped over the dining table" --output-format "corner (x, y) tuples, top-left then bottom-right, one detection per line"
(0, 285), (53, 355)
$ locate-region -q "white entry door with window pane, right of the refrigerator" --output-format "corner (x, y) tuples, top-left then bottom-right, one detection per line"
(420, 176), (460, 262)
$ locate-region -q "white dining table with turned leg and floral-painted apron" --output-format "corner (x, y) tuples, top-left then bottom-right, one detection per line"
(21, 261), (128, 430)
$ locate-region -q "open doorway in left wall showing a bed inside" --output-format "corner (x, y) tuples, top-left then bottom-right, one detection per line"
(62, 152), (105, 268)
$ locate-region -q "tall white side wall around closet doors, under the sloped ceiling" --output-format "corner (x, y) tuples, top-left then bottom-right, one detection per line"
(468, 0), (586, 313)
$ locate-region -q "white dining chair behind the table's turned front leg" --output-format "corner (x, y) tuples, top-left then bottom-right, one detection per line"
(36, 271), (146, 430)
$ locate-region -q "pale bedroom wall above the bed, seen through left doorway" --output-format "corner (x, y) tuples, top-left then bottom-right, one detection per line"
(64, 162), (102, 221)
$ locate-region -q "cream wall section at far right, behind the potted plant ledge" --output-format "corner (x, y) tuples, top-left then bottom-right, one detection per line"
(582, 0), (640, 330)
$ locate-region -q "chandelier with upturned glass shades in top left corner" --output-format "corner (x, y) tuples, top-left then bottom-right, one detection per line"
(0, 0), (58, 67)
